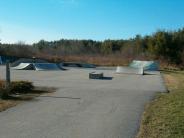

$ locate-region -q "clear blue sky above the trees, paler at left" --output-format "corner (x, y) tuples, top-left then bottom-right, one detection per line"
(0, 0), (184, 43)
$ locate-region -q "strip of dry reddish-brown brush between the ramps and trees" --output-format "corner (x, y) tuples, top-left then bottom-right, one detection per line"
(36, 53), (183, 71)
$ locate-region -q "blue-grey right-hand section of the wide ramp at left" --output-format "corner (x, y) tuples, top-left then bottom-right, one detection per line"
(34, 63), (61, 71)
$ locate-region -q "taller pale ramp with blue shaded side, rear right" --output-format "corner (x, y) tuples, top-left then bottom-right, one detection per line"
(129, 60), (159, 71)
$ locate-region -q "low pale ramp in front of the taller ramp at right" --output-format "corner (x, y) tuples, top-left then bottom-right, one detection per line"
(116, 66), (144, 75)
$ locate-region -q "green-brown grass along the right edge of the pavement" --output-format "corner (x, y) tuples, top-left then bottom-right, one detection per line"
(137, 71), (184, 138)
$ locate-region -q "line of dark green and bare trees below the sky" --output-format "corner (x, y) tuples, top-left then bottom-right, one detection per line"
(0, 28), (184, 65)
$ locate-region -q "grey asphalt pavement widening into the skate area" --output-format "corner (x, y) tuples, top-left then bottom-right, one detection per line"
(0, 66), (166, 138)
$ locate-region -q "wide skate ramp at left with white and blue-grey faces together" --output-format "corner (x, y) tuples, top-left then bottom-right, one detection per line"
(12, 63), (61, 71)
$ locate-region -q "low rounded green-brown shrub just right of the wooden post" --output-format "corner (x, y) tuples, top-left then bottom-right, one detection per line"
(11, 81), (34, 93)
